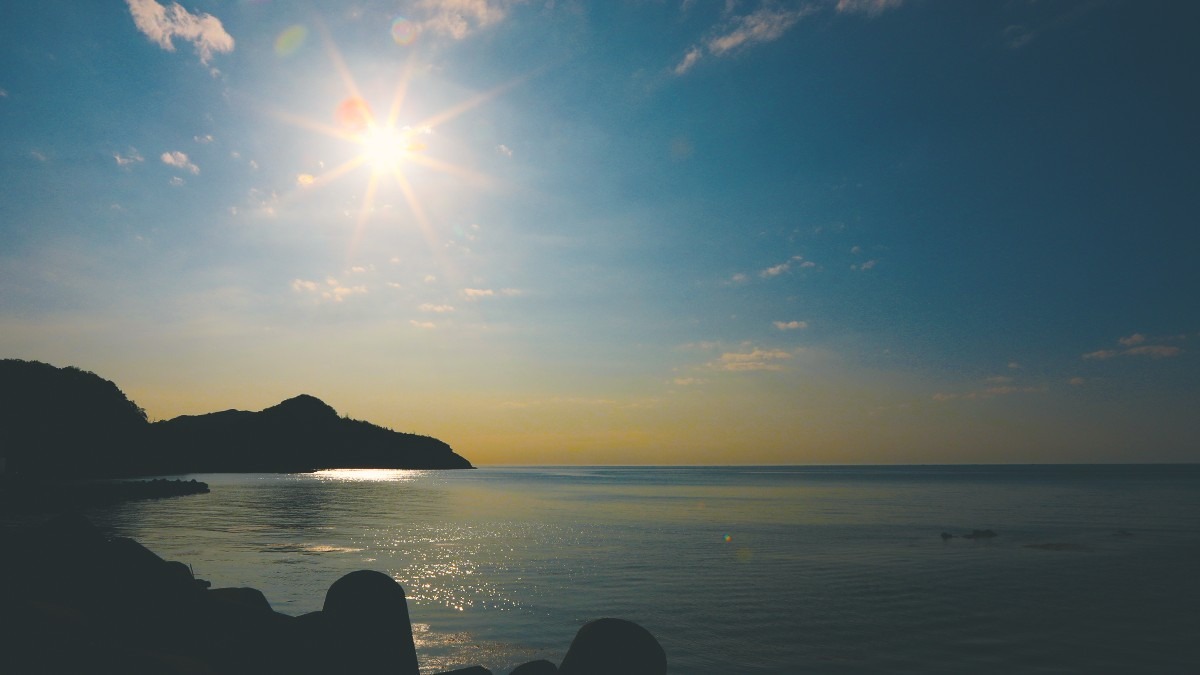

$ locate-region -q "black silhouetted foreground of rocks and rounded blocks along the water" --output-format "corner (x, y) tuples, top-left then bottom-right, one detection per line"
(0, 515), (667, 675)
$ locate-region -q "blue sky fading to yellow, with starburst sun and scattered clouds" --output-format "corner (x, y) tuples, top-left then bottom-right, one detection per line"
(0, 0), (1200, 465)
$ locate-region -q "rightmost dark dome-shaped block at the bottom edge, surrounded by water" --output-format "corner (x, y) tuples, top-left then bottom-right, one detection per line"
(558, 619), (667, 675)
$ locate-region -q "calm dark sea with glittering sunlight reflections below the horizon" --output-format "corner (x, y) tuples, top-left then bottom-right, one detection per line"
(91, 466), (1200, 674)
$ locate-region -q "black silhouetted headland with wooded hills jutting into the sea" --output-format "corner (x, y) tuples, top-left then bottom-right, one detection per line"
(0, 359), (473, 480)
